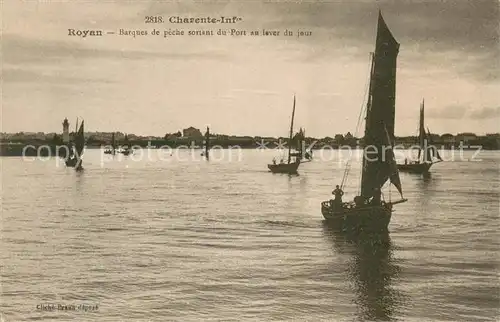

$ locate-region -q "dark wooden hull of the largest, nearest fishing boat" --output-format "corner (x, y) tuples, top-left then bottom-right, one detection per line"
(321, 201), (392, 232)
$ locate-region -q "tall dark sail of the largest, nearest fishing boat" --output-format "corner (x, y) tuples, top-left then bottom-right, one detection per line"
(361, 12), (402, 198)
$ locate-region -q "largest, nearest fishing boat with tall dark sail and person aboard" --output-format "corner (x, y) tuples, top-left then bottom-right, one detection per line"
(321, 11), (407, 231)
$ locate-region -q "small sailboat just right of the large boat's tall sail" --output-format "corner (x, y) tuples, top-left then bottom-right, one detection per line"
(398, 100), (443, 173)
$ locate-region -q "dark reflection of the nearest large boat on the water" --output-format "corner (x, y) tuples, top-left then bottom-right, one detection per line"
(324, 223), (403, 321)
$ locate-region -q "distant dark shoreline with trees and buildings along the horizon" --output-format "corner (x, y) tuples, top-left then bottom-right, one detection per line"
(0, 127), (500, 156)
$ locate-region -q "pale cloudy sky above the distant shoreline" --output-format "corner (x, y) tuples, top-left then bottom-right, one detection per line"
(0, 0), (500, 137)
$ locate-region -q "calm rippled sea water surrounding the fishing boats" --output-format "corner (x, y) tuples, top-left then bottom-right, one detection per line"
(0, 150), (500, 321)
